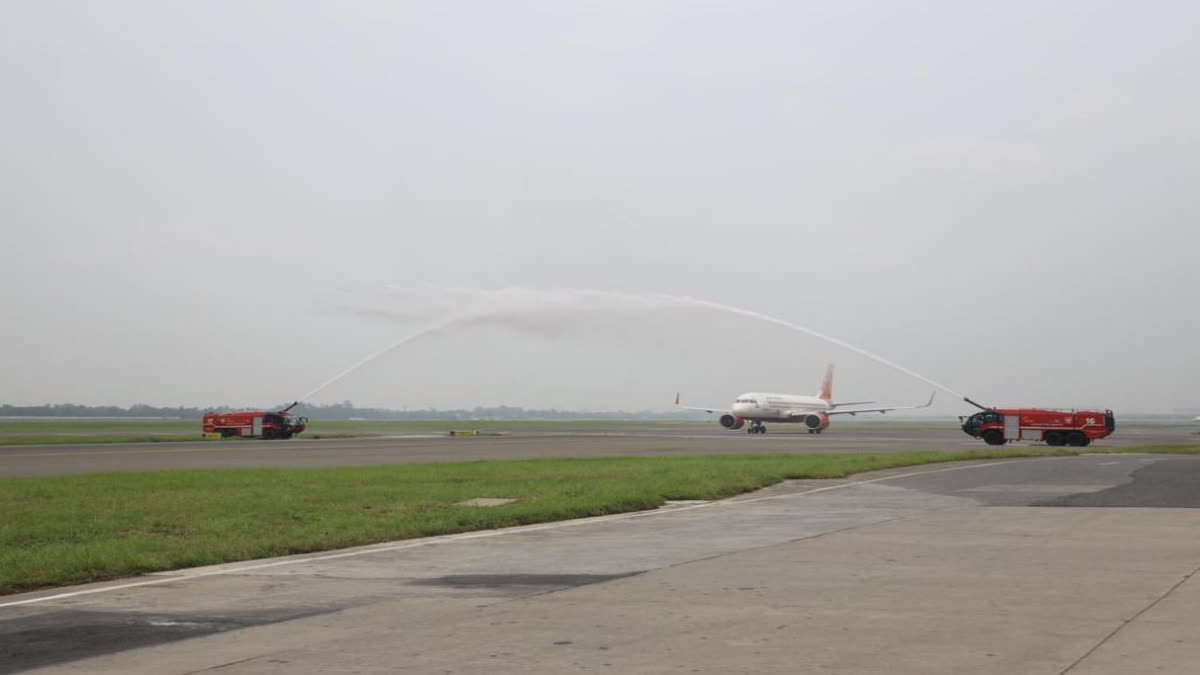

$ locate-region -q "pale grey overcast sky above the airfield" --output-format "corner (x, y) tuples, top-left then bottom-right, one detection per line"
(0, 0), (1200, 414)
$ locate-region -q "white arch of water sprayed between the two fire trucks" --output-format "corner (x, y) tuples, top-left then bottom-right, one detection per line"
(301, 288), (983, 407)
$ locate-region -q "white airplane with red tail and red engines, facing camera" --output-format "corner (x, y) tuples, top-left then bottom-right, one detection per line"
(676, 364), (936, 434)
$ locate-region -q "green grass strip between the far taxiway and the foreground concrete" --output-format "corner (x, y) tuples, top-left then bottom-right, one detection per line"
(0, 444), (1200, 593)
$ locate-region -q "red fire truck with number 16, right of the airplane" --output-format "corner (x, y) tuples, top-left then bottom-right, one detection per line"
(959, 408), (1116, 447)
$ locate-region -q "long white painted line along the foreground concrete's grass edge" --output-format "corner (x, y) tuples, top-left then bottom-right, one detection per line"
(0, 458), (1051, 608)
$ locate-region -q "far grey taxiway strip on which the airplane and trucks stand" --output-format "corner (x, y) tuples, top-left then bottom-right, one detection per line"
(0, 424), (1196, 476)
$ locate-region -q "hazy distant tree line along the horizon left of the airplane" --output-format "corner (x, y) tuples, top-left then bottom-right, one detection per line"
(0, 401), (704, 420)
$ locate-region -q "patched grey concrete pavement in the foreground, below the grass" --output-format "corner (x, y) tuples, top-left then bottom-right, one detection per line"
(7, 455), (1200, 675)
